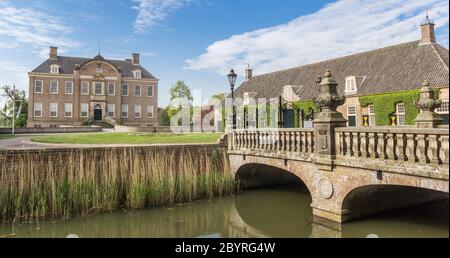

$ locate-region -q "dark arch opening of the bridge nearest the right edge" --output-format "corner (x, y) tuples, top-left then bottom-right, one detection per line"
(342, 184), (449, 222)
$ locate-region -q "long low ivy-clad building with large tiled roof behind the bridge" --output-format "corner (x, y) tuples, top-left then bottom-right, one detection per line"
(229, 17), (449, 128)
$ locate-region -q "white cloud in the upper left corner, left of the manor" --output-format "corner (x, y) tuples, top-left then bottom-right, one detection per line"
(0, 5), (79, 55)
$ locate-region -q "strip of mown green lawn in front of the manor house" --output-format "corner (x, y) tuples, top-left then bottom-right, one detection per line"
(31, 133), (221, 144)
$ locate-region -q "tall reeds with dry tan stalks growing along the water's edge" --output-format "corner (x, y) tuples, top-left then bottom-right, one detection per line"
(0, 147), (235, 221)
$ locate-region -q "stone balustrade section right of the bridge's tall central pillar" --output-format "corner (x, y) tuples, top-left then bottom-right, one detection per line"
(335, 127), (449, 165)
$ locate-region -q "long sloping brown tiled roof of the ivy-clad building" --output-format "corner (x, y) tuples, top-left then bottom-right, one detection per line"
(236, 41), (449, 100)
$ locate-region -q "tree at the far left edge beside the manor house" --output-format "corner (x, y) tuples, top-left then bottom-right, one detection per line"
(0, 85), (28, 127)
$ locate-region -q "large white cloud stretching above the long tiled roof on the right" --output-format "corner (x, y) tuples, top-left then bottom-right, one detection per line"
(186, 0), (449, 75)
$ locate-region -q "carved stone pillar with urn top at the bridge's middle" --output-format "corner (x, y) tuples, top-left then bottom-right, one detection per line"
(314, 70), (347, 171)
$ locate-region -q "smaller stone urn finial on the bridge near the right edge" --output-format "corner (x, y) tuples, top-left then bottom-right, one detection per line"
(415, 80), (443, 128)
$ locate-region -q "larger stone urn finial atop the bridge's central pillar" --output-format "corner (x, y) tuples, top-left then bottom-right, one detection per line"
(316, 70), (345, 113)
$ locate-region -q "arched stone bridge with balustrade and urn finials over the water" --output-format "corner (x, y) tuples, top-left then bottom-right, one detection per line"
(228, 71), (449, 225)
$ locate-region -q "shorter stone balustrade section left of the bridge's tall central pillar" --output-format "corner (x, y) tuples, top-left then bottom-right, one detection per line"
(230, 128), (314, 154)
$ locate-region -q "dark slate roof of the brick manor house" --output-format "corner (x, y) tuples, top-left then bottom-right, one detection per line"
(32, 56), (156, 79)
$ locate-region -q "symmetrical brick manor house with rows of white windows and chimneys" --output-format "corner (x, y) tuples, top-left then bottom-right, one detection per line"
(27, 47), (158, 127)
